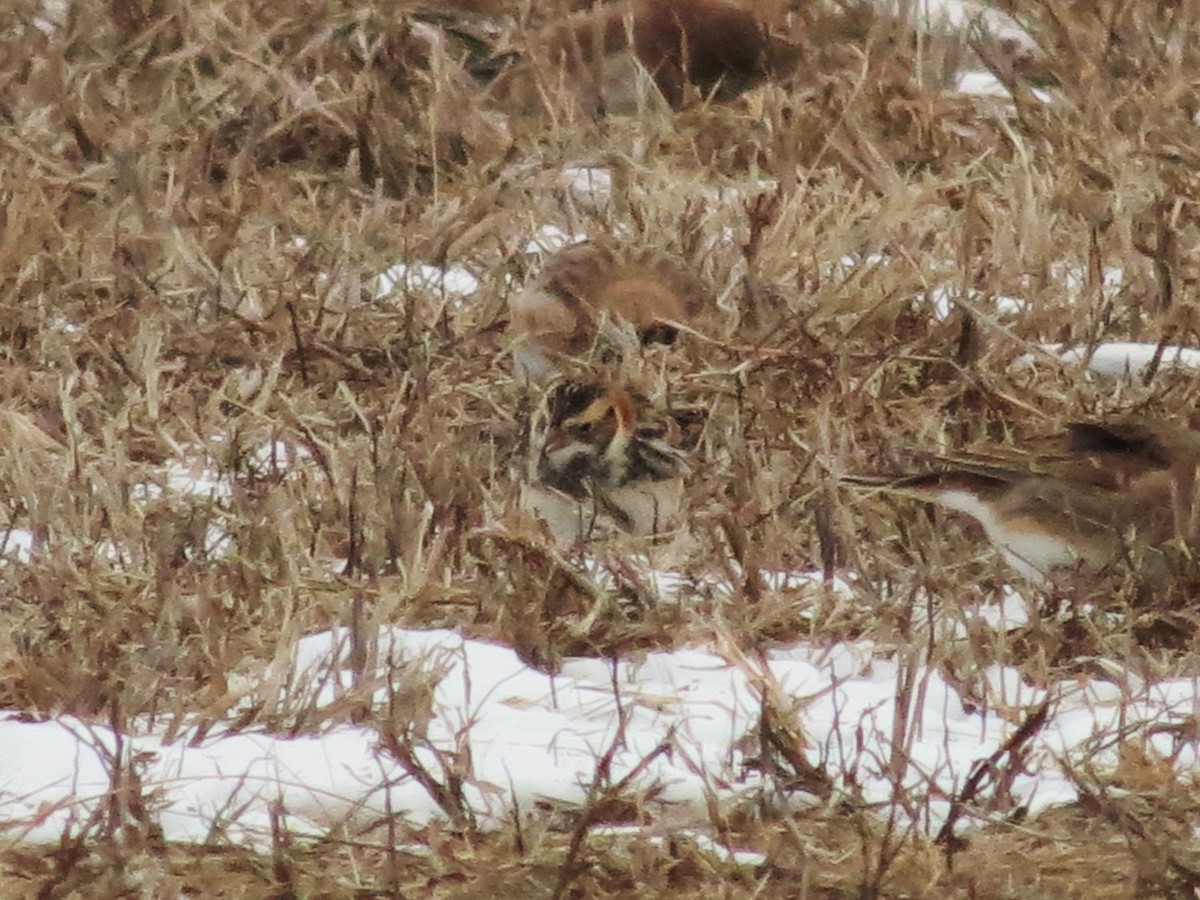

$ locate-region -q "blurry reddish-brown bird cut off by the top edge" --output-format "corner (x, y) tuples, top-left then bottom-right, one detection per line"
(482, 0), (799, 115)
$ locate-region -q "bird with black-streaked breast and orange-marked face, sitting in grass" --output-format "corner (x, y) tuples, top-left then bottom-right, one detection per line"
(522, 383), (688, 545)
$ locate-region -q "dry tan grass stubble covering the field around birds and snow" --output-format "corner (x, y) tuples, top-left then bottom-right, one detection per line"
(0, 0), (1200, 898)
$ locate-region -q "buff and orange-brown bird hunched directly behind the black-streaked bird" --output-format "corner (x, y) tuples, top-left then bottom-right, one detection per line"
(508, 241), (706, 384)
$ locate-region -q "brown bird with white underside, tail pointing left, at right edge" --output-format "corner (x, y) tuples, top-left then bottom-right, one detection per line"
(844, 418), (1200, 581)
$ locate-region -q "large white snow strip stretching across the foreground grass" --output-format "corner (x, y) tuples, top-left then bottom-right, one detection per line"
(7, 609), (1200, 862)
